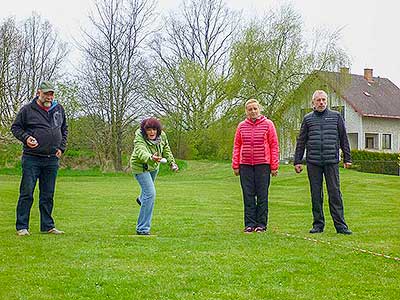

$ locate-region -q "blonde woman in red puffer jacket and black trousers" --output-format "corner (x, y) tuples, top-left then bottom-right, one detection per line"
(232, 99), (279, 233)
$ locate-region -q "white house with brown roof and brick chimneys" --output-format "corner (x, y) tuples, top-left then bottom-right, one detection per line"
(320, 68), (400, 153)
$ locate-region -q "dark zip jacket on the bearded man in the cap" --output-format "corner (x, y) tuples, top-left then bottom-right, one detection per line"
(11, 97), (68, 157)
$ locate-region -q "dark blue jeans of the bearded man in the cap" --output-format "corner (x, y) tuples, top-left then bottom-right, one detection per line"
(16, 155), (58, 231)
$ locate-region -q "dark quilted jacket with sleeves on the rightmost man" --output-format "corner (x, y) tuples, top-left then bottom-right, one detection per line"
(294, 109), (351, 166)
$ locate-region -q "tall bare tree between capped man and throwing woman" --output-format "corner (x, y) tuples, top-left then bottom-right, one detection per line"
(80, 0), (154, 170)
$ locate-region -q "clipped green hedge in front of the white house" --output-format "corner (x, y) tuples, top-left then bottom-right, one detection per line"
(351, 150), (400, 175)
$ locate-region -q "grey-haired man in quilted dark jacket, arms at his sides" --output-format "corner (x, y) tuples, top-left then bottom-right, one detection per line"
(294, 90), (352, 234)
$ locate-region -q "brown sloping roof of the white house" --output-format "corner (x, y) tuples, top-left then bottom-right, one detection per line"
(316, 71), (400, 119)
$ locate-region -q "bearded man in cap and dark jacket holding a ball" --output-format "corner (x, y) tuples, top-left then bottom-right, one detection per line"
(11, 81), (68, 236)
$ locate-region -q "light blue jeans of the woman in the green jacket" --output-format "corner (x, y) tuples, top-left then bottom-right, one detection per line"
(135, 169), (158, 233)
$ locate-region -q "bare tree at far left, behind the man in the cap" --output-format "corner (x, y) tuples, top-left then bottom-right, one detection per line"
(0, 14), (68, 139)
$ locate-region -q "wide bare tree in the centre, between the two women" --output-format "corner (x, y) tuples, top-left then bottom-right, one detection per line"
(146, 0), (238, 131)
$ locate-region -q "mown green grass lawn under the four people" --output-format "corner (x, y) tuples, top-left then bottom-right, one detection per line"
(0, 162), (400, 300)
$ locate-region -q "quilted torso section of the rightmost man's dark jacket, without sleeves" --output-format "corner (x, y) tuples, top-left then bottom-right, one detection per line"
(304, 109), (340, 165)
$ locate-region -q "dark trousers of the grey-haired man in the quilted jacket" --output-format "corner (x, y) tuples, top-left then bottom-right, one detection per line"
(307, 164), (347, 230)
